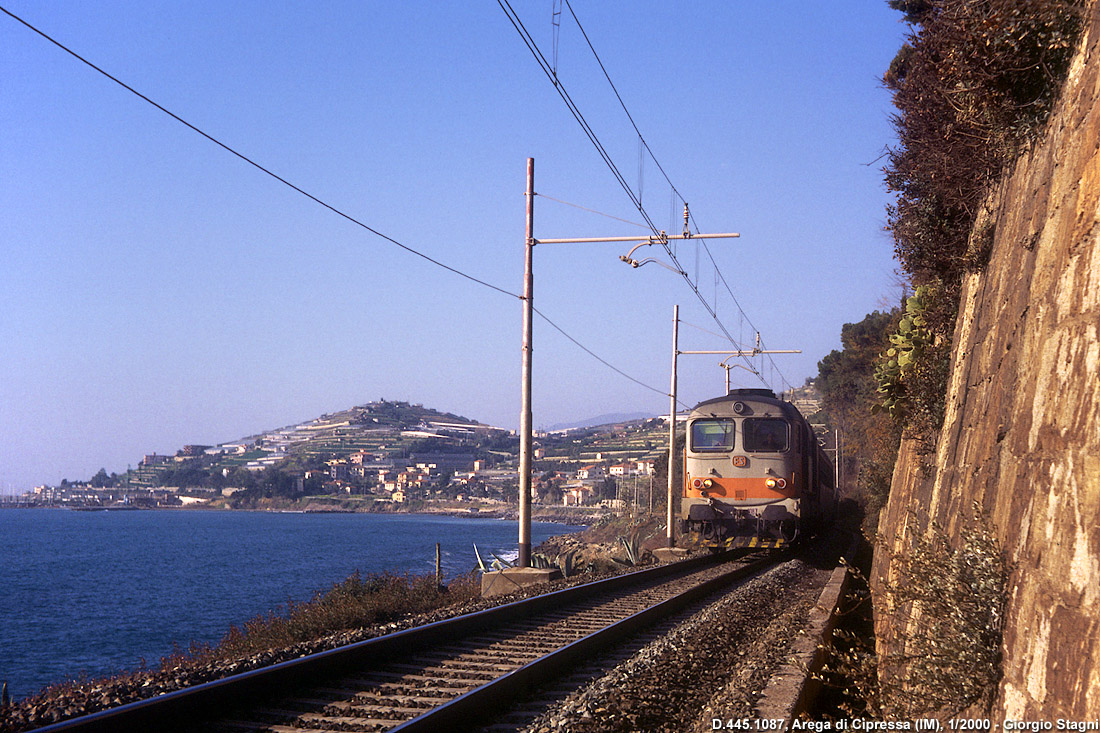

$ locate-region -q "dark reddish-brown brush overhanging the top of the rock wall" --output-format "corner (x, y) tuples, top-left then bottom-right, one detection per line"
(881, 0), (1085, 453)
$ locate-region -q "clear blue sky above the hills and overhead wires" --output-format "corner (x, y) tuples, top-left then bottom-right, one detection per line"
(0, 0), (906, 492)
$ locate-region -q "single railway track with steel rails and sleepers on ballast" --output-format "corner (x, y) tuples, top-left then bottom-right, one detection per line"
(40, 548), (780, 733)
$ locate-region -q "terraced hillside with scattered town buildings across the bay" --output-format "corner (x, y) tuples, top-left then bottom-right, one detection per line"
(3, 386), (821, 512)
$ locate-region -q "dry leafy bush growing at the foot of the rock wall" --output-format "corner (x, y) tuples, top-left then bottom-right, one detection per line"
(821, 506), (1010, 720)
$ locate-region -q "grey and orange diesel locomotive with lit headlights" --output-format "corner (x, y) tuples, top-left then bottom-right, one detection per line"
(680, 390), (837, 550)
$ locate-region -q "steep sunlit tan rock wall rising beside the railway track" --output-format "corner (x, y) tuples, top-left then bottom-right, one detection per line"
(872, 7), (1100, 722)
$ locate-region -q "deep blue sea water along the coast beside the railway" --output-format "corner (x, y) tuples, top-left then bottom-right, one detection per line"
(0, 501), (582, 699)
